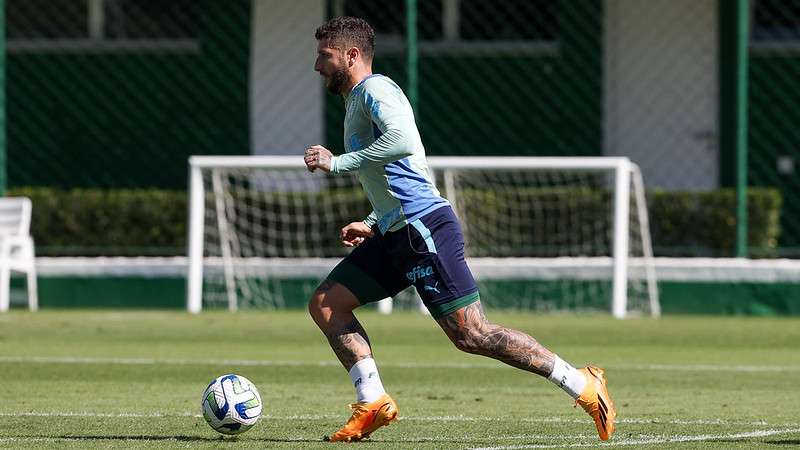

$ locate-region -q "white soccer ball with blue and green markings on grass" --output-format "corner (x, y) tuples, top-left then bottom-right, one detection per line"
(201, 374), (263, 434)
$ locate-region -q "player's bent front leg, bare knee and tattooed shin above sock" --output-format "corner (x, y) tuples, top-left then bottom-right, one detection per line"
(308, 280), (372, 371)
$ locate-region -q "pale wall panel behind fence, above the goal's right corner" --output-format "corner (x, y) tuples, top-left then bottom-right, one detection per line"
(603, 0), (719, 190)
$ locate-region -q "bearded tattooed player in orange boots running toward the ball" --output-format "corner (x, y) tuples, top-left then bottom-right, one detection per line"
(304, 17), (616, 442)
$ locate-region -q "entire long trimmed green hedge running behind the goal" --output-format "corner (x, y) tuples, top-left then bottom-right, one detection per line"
(9, 187), (782, 256)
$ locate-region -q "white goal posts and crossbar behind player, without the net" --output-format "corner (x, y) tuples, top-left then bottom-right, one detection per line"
(186, 156), (661, 318)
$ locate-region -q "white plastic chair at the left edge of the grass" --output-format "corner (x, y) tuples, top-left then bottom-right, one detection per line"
(0, 197), (39, 312)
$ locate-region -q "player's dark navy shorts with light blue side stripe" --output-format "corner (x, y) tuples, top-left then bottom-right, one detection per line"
(328, 206), (479, 319)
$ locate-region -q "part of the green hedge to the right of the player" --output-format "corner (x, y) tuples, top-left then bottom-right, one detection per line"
(459, 187), (782, 257)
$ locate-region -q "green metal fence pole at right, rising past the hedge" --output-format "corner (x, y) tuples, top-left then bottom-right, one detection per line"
(735, 0), (750, 258)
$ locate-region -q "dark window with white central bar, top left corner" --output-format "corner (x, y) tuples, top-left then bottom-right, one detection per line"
(5, 0), (200, 51)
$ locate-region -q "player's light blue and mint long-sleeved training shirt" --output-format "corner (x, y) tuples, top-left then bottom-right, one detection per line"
(331, 74), (449, 233)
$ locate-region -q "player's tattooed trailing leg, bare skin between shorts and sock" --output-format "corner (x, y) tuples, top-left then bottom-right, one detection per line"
(437, 301), (555, 377)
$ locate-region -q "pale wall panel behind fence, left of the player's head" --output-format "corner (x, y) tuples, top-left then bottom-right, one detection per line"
(250, 0), (325, 155)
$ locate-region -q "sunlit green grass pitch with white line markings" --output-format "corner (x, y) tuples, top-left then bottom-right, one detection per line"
(0, 311), (800, 449)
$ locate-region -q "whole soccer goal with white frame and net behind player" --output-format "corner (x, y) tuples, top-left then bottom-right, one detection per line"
(187, 156), (660, 317)
